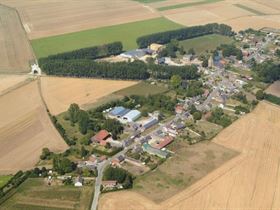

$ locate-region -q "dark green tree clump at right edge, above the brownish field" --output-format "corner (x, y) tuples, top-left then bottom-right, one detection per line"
(253, 61), (280, 83)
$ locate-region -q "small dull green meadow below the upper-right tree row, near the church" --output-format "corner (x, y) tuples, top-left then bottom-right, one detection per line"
(180, 34), (233, 54)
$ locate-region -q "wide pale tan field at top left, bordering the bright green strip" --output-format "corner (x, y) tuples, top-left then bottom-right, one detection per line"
(0, 0), (159, 39)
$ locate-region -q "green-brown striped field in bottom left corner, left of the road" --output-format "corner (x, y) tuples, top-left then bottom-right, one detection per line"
(0, 178), (93, 210)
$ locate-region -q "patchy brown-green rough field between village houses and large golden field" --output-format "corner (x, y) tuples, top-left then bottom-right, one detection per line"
(133, 139), (237, 202)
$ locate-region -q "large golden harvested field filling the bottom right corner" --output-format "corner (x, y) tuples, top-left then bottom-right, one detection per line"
(100, 102), (280, 210)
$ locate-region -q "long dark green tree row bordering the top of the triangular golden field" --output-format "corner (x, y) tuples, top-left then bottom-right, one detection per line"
(41, 59), (199, 80)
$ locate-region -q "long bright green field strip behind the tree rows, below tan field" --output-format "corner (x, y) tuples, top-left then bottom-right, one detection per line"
(31, 17), (182, 58)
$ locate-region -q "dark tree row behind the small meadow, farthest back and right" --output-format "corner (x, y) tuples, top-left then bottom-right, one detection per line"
(137, 23), (233, 48)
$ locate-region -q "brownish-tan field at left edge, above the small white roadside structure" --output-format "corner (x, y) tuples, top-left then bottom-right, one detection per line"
(0, 5), (34, 74)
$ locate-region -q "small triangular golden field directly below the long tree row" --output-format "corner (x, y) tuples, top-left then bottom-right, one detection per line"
(41, 77), (137, 115)
